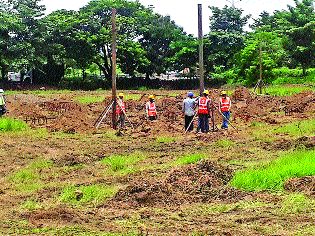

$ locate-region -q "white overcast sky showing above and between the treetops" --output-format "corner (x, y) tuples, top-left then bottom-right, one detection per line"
(42, 0), (294, 35)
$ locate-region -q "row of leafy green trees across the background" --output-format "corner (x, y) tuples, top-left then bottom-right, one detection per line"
(0, 0), (315, 86)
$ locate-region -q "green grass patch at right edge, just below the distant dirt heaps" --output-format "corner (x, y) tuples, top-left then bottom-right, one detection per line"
(273, 119), (315, 137)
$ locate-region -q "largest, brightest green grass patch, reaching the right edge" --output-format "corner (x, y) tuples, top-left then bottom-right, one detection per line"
(231, 150), (315, 191)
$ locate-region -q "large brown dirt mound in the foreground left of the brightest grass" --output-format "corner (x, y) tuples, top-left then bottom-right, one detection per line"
(114, 161), (244, 205)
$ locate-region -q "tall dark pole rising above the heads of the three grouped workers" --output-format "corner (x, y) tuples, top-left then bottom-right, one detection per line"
(198, 4), (205, 95)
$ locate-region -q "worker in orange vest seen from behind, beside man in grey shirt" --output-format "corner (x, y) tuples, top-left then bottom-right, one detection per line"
(197, 90), (211, 133)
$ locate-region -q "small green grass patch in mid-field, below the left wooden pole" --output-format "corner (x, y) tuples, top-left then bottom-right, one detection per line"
(101, 152), (145, 175)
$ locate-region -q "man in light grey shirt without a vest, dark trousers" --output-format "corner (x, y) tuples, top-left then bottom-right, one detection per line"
(182, 92), (196, 131)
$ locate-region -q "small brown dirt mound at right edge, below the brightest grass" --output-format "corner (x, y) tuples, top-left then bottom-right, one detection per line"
(284, 176), (315, 197)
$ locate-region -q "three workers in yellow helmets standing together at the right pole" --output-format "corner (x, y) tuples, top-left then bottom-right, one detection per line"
(182, 90), (231, 133)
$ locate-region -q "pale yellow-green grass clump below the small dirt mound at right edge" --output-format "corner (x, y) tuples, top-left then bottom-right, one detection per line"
(281, 193), (315, 214)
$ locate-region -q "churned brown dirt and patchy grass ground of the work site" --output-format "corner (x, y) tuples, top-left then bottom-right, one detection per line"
(0, 88), (315, 235)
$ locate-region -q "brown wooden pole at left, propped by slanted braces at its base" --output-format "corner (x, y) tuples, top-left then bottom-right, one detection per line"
(112, 8), (117, 129)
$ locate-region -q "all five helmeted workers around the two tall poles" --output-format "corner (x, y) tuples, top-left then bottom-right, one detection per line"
(116, 90), (231, 133)
